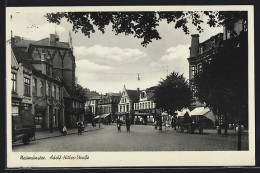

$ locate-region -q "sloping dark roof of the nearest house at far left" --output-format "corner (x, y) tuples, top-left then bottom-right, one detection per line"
(12, 47), (34, 69)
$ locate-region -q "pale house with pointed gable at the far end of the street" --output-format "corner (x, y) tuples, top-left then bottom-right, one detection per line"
(117, 86), (140, 123)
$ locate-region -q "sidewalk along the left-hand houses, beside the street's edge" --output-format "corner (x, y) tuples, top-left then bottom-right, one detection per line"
(35, 125), (103, 140)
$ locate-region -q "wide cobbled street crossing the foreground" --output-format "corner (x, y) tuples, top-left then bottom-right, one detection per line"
(13, 124), (248, 152)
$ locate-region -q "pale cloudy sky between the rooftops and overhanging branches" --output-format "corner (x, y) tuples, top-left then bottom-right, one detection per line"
(9, 12), (223, 94)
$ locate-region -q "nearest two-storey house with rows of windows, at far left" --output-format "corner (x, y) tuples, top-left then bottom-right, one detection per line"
(12, 46), (64, 129)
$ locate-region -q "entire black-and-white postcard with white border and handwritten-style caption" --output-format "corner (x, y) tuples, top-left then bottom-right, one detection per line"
(6, 5), (255, 168)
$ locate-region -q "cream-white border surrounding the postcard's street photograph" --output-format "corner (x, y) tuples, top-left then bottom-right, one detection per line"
(6, 5), (255, 168)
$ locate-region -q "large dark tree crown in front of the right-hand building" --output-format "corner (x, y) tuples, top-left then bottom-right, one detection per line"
(195, 33), (248, 125)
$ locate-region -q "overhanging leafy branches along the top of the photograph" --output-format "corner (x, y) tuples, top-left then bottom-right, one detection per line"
(45, 11), (247, 46)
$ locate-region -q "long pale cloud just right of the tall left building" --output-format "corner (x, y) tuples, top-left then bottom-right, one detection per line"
(74, 45), (147, 64)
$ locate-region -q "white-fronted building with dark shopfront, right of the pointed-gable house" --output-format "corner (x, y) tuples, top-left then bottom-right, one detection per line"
(134, 87), (156, 124)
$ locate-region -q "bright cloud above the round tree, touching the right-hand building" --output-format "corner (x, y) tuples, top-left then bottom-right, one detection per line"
(150, 45), (189, 79)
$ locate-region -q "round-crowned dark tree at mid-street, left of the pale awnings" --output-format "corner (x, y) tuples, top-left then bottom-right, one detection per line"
(154, 72), (192, 115)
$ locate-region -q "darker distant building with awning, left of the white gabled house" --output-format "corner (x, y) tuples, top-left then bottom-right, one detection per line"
(98, 93), (121, 124)
